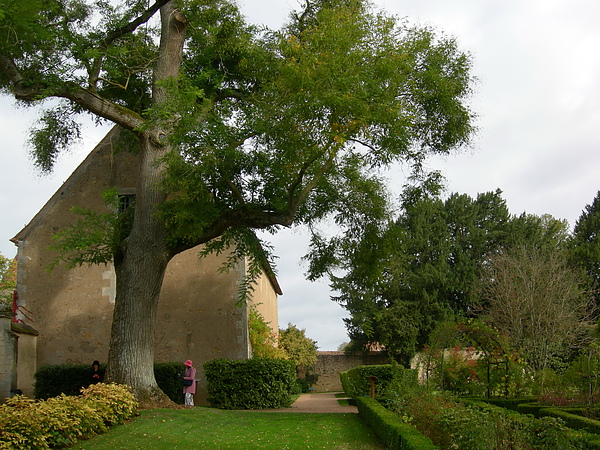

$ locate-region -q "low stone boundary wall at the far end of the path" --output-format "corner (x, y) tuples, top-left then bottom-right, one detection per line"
(313, 352), (389, 392)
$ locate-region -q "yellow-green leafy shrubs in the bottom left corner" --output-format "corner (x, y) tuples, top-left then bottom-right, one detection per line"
(0, 383), (138, 450)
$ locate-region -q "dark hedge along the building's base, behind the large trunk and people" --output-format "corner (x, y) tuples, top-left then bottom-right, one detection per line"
(34, 362), (185, 404)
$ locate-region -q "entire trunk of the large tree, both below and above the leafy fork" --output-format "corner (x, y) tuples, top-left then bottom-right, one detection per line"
(107, 2), (185, 406)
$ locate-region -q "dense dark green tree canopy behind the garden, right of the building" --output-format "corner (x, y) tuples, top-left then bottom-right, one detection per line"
(326, 187), (568, 358)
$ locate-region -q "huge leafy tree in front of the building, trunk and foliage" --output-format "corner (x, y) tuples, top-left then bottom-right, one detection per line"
(0, 0), (472, 401)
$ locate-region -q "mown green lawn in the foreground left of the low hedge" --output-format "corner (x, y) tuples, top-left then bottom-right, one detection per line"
(71, 407), (384, 450)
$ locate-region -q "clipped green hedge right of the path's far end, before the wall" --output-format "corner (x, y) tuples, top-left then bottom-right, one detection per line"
(340, 364), (417, 398)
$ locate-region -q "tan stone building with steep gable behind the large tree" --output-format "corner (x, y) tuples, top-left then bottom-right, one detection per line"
(12, 129), (281, 401)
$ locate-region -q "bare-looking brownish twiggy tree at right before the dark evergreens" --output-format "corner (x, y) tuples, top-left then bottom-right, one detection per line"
(481, 247), (593, 371)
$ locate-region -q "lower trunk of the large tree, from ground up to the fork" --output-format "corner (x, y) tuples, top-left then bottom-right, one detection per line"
(107, 131), (171, 405)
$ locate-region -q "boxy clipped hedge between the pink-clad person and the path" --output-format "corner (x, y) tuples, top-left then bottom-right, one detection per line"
(204, 358), (296, 409)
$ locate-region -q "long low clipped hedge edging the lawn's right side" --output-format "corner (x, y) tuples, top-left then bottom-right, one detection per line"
(356, 397), (437, 450)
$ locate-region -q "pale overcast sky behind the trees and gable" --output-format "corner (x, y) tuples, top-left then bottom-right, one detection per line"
(0, 0), (600, 350)
